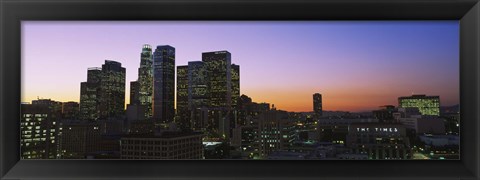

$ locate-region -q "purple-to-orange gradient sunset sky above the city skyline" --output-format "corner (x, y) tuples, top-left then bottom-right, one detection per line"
(21, 21), (459, 111)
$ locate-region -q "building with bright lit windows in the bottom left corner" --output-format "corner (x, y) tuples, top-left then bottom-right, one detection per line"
(20, 104), (60, 159)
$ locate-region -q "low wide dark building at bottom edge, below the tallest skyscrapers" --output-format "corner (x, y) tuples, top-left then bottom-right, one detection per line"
(120, 131), (203, 159)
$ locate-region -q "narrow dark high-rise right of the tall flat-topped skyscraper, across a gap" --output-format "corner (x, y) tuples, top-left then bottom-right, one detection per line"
(176, 66), (191, 129)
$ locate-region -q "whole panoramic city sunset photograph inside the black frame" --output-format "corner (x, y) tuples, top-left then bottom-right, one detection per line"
(19, 21), (461, 160)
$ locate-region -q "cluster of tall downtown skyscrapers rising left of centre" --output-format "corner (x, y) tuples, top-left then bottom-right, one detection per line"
(79, 45), (240, 138)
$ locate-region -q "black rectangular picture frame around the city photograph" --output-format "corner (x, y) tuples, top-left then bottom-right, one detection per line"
(0, 0), (480, 180)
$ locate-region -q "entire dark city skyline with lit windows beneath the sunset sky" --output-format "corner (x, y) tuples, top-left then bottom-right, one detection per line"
(20, 45), (460, 159)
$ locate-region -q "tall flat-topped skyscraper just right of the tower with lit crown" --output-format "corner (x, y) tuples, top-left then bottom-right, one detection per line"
(153, 45), (175, 124)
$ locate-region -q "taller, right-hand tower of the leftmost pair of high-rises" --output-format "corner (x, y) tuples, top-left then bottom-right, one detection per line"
(99, 60), (125, 119)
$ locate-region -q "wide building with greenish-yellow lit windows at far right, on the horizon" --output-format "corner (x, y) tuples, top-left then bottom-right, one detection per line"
(398, 95), (440, 116)
